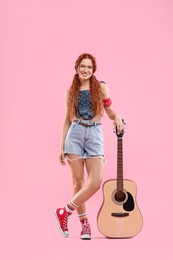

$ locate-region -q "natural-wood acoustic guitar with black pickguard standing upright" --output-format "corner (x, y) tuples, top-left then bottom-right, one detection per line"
(97, 123), (143, 238)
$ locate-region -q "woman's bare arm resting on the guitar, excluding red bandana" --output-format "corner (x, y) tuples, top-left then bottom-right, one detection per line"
(100, 83), (124, 133)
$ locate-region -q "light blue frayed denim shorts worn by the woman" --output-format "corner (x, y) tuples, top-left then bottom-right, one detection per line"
(64, 121), (104, 159)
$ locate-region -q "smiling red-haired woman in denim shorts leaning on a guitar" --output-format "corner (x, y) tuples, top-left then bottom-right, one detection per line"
(55, 53), (124, 239)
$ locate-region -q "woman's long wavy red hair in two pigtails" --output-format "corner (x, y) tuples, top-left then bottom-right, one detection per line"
(68, 53), (103, 119)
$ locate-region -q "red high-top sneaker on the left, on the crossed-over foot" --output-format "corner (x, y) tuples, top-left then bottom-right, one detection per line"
(55, 208), (71, 237)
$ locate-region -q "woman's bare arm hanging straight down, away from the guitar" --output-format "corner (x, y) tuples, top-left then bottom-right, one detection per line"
(59, 91), (71, 165)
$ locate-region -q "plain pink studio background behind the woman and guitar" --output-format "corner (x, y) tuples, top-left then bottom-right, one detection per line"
(0, 0), (173, 260)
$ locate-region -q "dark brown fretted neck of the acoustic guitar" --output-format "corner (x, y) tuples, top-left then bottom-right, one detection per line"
(117, 138), (123, 191)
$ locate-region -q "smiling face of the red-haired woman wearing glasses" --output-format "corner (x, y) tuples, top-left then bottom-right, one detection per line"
(77, 59), (93, 80)
